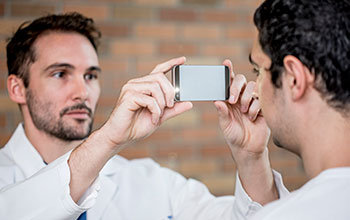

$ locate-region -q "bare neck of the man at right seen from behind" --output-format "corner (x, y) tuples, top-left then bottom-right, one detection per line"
(300, 106), (350, 178)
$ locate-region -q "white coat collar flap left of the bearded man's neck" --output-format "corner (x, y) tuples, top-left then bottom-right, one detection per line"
(5, 123), (45, 178)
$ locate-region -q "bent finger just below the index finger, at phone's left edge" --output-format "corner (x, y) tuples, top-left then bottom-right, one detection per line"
(133, 73), (175, 108)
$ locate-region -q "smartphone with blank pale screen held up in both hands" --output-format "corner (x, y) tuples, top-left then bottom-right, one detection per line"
(172, 65), (230, 101)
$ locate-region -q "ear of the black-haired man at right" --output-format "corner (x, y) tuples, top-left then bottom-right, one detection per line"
(283, 55), (315, 100)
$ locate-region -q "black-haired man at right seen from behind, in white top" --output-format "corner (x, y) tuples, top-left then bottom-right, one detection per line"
(235, 0), (350, 220)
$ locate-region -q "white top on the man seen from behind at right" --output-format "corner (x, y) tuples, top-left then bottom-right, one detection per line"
(253, 167), (350, 220)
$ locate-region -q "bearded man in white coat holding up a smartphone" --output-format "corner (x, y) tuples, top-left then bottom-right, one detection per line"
(0, 13), (285, 220)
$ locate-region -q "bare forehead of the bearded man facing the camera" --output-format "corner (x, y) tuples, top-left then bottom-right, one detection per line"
(33, 32), (98, 65)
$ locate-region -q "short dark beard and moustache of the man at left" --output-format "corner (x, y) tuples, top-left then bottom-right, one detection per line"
(26, 89), (93, 141)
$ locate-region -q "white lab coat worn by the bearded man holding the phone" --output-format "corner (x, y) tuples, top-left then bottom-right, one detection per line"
(0, 125), (288, 220)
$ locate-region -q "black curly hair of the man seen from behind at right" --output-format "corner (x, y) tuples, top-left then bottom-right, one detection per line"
(254, 0), (350, 113)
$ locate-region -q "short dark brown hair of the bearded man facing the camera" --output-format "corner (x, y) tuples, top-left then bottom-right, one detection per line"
(6, 12), (101, 87)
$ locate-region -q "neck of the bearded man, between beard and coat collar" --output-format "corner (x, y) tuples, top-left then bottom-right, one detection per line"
(24, 113), (82, 163)
